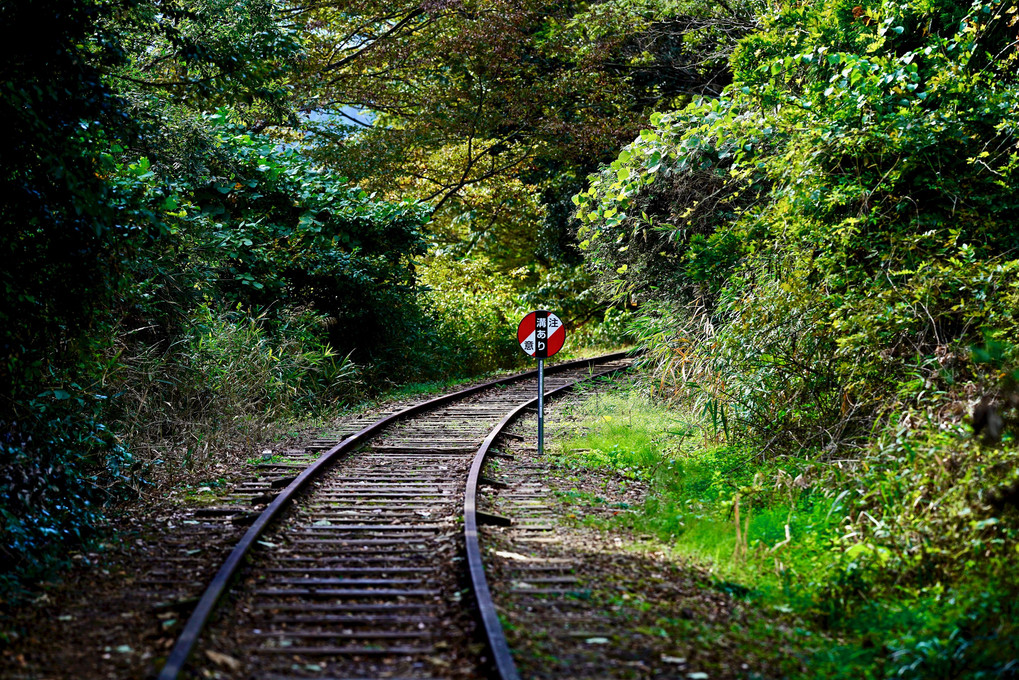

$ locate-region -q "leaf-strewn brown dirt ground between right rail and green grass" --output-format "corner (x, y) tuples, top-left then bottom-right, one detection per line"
(482, 385), (804, 680)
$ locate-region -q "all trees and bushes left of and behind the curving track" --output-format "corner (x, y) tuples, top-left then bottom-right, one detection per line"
(0, 0), (733, 586)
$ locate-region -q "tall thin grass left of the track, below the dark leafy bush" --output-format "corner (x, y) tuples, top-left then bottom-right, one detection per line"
(104, 304), (360, 477)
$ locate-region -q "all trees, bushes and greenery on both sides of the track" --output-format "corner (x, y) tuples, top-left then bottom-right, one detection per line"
(0, 0), (1019, 677)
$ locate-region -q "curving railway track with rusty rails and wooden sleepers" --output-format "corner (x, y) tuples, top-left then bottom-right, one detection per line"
(159, 354), (629, 680)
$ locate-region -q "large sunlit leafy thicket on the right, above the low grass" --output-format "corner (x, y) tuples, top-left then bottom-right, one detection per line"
(575, 1), (1019, 448)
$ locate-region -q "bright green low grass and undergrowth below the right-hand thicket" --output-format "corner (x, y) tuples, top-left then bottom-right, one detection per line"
(552, 385), (1019, 679)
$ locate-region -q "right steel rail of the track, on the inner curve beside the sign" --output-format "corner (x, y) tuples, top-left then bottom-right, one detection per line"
(464, 365), (630, 680)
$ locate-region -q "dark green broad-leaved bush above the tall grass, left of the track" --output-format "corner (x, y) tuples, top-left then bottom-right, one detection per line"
(134, 112), (425, 361)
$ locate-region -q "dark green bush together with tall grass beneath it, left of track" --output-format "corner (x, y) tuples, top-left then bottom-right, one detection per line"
(80, 109), (424, 456)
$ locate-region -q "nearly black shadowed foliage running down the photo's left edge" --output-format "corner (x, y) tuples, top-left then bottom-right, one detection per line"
(0, 0), (148, 594)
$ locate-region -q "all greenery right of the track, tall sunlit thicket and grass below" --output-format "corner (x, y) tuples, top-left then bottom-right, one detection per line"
(575, 0), (1019, 678)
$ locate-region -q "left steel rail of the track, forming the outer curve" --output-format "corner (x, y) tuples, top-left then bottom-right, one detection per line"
(158, 352), (627, 680)
